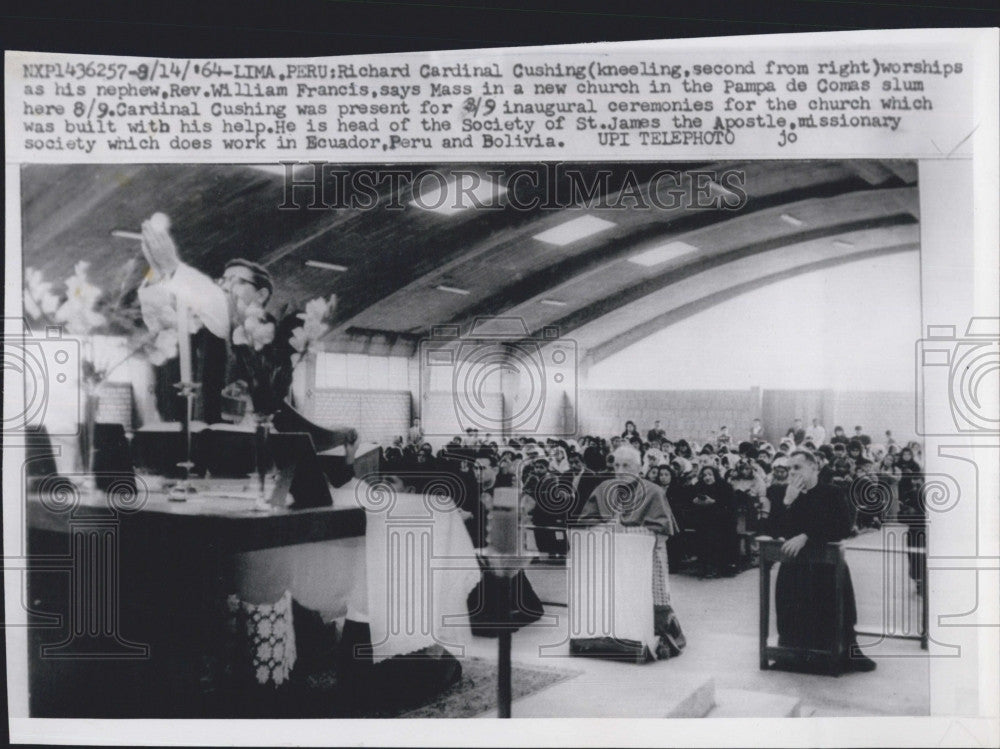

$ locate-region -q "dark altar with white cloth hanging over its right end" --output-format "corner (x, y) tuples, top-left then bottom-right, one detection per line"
(27, 470), (479, 717)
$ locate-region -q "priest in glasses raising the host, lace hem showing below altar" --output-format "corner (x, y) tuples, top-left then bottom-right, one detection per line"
(138, 214), (358, 688)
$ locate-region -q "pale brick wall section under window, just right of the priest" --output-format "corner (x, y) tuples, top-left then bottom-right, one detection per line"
(303, 388), (410, 443)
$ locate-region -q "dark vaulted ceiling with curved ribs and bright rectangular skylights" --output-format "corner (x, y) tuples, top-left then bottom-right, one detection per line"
(21, 161), (919, 362)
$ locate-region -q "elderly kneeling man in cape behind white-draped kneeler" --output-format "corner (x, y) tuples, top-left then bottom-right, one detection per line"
(580, 446), (685, 659)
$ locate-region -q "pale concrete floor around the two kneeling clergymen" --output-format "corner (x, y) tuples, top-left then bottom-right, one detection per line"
(470, 533), (929, 717)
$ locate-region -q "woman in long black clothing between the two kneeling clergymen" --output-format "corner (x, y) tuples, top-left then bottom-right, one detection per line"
(691, 465), (737, 577)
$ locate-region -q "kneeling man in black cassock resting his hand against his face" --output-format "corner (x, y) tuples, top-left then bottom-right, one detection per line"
(775, 450), (875, 671)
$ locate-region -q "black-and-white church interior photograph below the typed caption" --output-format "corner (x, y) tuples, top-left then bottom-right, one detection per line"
(15, 160), (929, 718)
